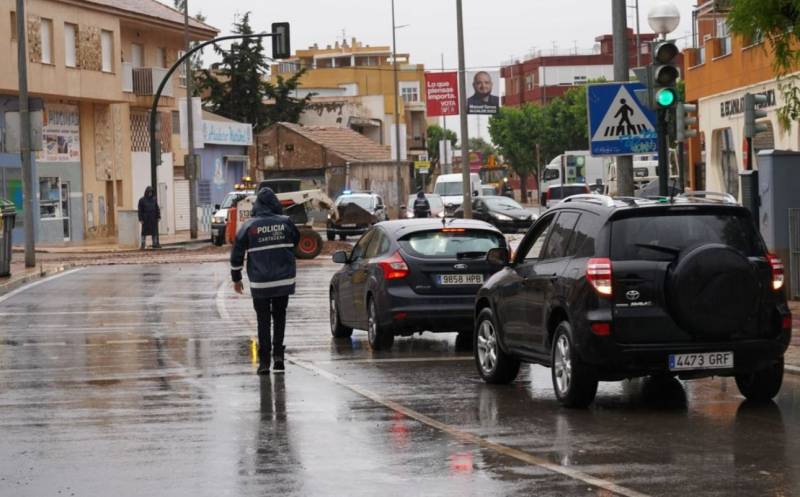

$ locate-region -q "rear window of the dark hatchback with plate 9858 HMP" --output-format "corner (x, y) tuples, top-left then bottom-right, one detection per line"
(399, 230), (505, 259)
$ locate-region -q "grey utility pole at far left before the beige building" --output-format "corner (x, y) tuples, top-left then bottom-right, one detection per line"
(17, 0), (36, 267)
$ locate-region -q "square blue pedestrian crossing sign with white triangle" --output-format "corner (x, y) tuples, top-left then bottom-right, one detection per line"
(586, 83), (658, 155)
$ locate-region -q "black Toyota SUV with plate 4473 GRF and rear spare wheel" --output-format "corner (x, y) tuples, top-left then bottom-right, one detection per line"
(474, 193), (792, 407)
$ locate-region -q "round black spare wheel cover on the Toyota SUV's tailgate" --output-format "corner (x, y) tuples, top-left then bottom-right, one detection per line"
(667, 243), (760, 337)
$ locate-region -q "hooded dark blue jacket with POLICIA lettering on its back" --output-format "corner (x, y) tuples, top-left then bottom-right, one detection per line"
(231, 188), (300, 299)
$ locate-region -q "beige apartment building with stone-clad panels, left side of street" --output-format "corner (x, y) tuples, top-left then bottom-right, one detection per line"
(0, 0), (217, 243)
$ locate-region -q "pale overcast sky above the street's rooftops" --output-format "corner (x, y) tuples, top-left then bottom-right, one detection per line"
(180, 0), (695, 69)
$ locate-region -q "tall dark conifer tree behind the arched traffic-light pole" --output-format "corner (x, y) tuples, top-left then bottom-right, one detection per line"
(199, 12), (313, 132)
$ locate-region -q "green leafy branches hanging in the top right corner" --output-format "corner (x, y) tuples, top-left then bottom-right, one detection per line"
(727, 0), (800, 129)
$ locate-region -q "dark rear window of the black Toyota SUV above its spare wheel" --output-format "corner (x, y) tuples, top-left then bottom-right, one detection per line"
(611, 213), (763, 261)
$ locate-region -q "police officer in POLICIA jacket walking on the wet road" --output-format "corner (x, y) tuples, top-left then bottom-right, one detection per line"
(231, 188), (300, 375)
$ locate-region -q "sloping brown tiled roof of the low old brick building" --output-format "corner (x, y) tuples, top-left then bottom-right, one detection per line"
(280, 123), (392, 161)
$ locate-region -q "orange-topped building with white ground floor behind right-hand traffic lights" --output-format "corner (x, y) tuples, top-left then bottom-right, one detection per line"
(683, 0), (800, 197)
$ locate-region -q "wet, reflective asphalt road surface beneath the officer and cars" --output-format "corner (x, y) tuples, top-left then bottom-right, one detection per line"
(0, 261), (800, 497)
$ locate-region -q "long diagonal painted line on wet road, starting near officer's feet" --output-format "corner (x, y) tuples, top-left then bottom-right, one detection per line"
(286, 354), (649, 497)
